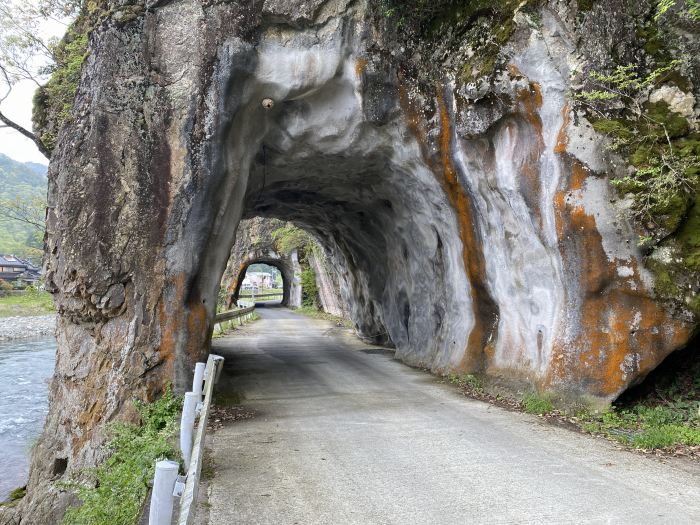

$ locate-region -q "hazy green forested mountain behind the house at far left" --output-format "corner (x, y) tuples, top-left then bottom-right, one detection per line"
(0, 153), (47, 262)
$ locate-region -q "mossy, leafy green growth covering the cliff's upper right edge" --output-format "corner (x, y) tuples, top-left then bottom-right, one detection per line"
(575, 0), (700, 315)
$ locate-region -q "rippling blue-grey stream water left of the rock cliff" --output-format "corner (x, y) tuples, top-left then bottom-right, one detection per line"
(0, 337), (56, 501)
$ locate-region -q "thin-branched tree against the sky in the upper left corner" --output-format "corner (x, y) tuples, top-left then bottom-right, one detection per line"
(0, 0), (81, 158)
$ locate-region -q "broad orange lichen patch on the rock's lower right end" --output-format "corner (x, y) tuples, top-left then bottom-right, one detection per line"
(547, 159), (689, 399)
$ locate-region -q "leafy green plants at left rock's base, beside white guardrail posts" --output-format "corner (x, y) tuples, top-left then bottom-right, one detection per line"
(63, 388), (182, 525)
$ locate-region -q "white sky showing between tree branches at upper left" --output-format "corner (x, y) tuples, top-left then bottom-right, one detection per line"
(0, 14), (66, 164)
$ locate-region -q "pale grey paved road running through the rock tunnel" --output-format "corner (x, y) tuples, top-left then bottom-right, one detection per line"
(209, 308), (700, 525)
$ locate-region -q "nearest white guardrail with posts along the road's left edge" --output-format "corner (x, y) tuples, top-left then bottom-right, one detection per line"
(148, 354), (224, 525)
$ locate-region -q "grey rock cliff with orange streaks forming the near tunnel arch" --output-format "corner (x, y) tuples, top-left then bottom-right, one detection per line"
(9, 0), (700, 523)
